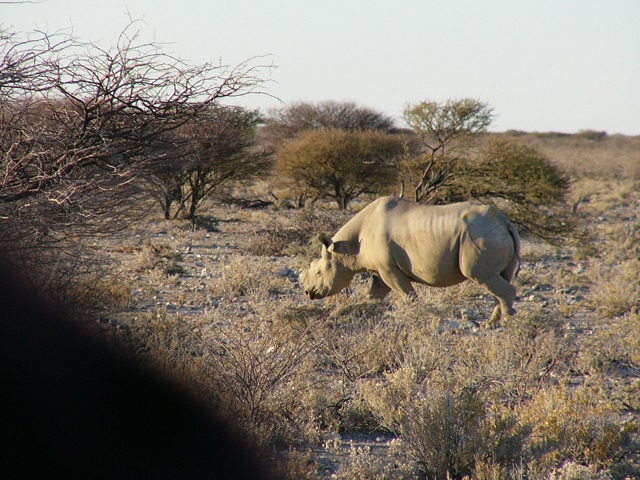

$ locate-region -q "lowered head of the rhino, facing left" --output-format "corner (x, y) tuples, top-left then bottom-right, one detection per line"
(300, 235), (355, 300)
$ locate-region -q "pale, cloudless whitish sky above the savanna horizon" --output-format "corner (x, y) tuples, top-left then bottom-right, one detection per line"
(0, 0), (640, 135)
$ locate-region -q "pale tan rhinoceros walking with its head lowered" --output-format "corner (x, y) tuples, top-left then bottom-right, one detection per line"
(300, 197), (520, 326)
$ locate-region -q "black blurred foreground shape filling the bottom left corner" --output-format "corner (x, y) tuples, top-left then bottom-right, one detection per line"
(0, 258), (270, 480)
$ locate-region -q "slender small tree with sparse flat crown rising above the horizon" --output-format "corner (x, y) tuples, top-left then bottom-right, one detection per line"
(403, 98), (493, 203)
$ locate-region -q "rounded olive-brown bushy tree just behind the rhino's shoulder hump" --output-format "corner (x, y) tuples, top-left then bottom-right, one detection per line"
(276, 129), (404, 210)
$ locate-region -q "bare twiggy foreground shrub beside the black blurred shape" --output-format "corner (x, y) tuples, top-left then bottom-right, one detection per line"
(201, 316), (315, 444)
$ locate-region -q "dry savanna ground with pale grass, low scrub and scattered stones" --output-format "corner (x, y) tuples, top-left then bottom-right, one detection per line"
(89, 132), (640, 479)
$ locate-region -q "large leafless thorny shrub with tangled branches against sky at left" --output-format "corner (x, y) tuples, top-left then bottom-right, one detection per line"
(0, 22), (265, 308)
